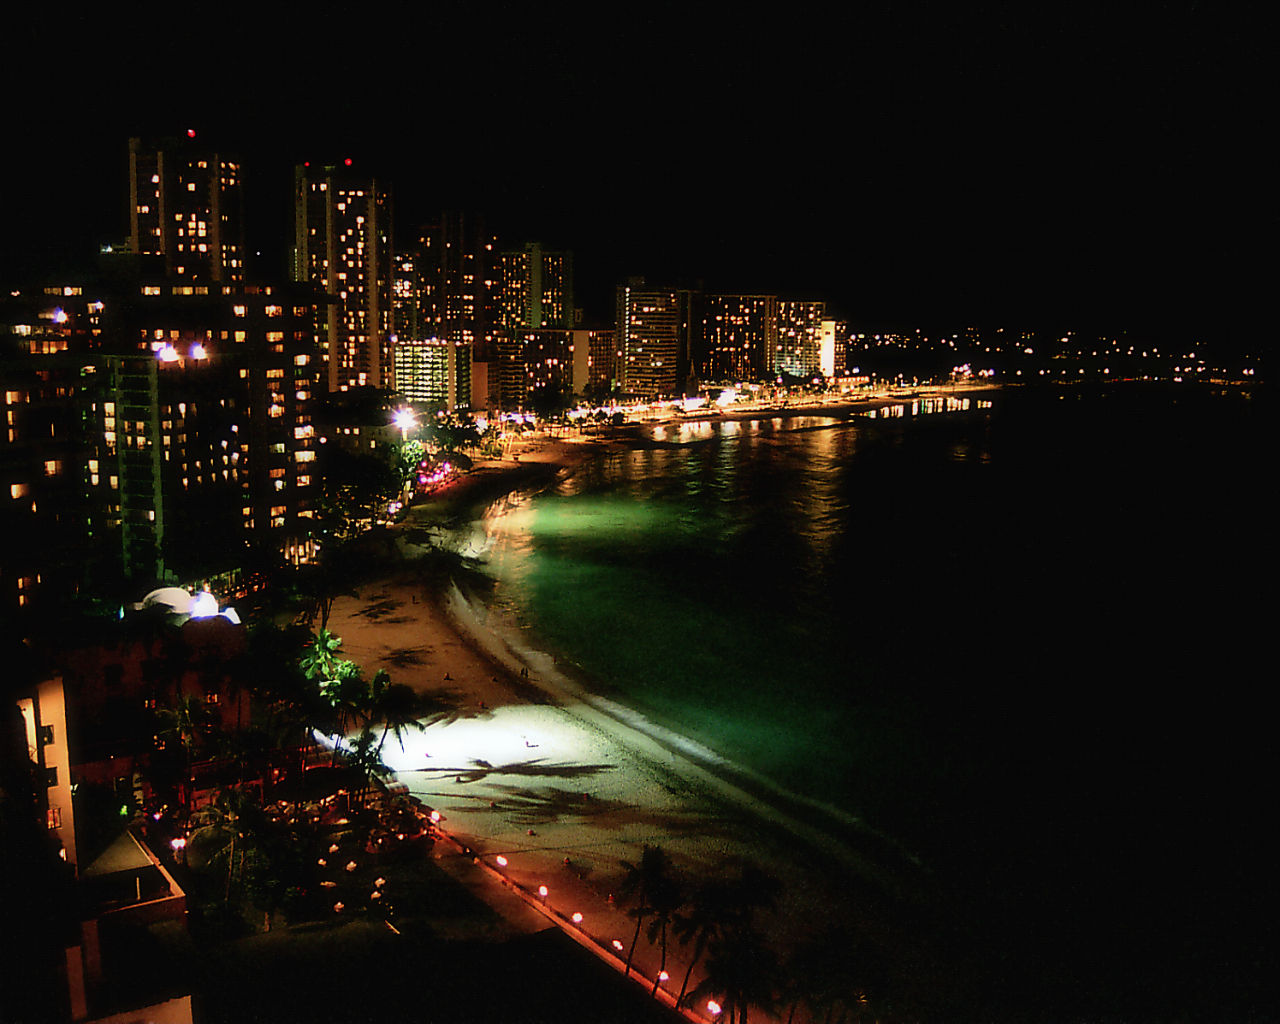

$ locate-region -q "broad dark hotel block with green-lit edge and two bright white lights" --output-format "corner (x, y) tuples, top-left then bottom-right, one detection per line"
(93, 283), (319, 581)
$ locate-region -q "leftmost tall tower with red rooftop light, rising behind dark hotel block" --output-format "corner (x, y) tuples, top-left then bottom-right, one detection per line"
(129, 132), (244, 282)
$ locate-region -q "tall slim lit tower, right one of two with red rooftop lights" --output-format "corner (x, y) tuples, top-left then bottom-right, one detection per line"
(293, 164), (393, 392)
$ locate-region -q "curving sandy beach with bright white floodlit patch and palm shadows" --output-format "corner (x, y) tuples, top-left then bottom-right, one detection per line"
(329, 399), (983, 1021)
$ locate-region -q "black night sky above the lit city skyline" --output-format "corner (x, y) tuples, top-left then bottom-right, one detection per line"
(0, 3), (1259, 348)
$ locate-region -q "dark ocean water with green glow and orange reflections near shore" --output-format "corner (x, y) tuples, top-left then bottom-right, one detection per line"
(465, 387), (1275, 1020)
